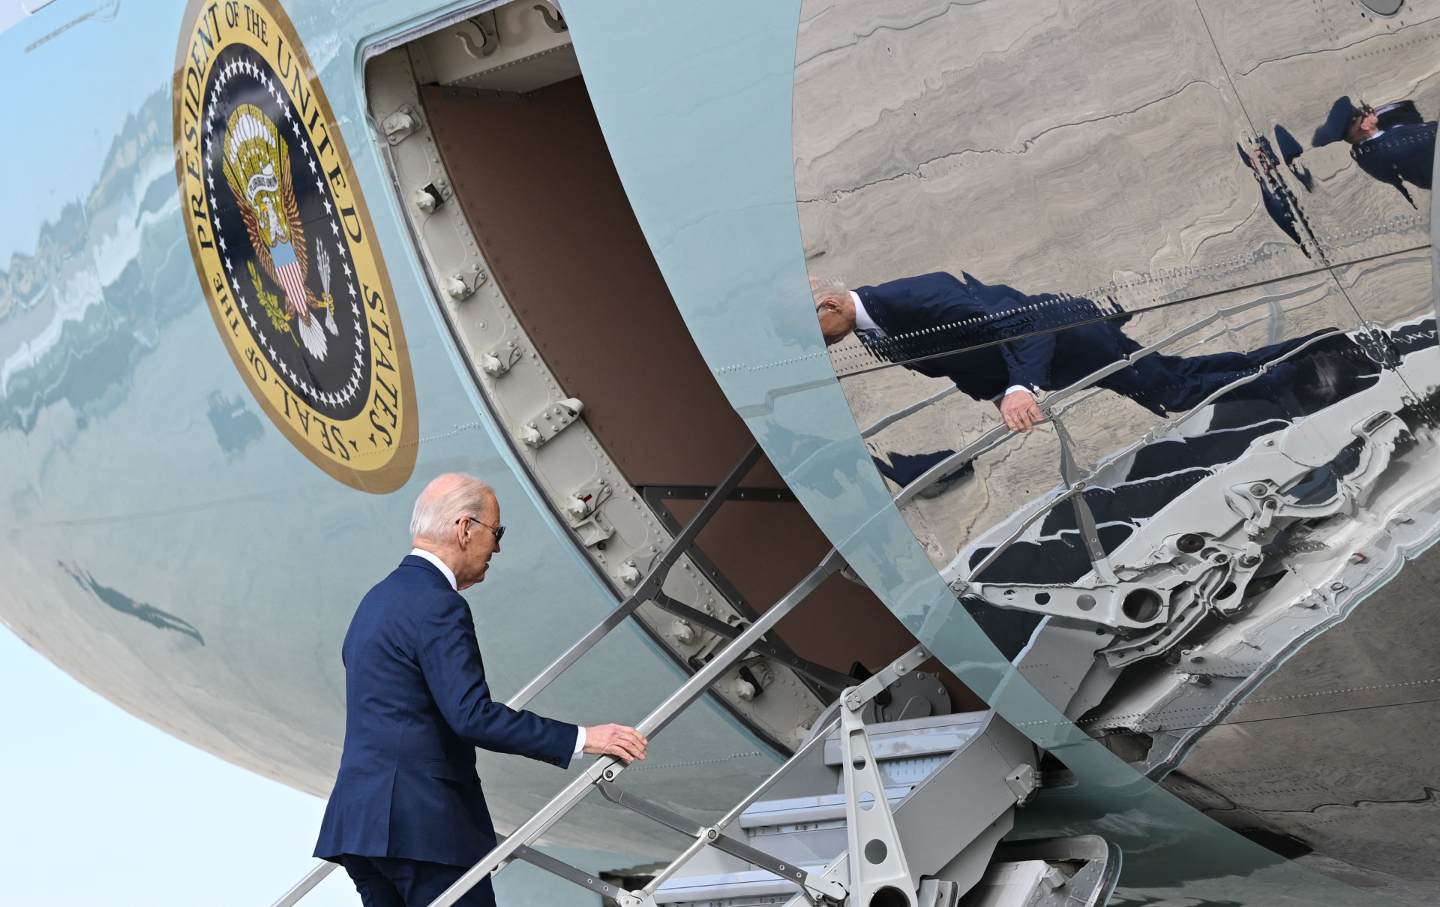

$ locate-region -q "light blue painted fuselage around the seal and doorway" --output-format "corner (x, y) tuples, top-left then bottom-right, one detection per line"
(0, 0), (1434, 904)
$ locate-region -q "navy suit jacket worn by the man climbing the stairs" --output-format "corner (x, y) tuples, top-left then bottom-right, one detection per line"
(315, 556), (576, 867)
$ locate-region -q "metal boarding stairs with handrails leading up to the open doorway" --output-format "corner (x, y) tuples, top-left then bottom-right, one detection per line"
(274, 448), (1119, 907)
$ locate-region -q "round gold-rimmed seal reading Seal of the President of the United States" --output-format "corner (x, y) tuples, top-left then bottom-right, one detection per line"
(174, 0), (416, 494)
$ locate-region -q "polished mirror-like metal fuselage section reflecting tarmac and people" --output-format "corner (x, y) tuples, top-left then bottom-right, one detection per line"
(793, 0), (1440, 904)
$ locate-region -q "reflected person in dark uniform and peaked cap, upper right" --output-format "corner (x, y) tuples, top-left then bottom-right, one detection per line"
(1313, 95), (1436, 207)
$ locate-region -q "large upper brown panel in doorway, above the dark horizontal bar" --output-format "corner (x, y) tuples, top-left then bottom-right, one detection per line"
(420, 79), (760, 485)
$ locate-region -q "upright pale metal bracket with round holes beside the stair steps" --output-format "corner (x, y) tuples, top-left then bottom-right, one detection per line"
(840, 688), (920, 907)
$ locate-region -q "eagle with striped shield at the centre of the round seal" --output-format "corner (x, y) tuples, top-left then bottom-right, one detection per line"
(223, 104), (338, 361)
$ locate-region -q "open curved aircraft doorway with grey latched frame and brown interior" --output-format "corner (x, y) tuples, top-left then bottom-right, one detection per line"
(367, 6), (979, 750)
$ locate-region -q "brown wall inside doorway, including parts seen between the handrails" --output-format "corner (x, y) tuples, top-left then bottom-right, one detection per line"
(420, 79), (979, 714)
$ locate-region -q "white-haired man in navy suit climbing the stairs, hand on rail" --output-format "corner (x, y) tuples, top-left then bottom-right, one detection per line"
(315, 474), (645, 907)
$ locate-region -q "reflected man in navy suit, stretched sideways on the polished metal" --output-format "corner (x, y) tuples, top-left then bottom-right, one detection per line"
(812, 272), (1336, 432)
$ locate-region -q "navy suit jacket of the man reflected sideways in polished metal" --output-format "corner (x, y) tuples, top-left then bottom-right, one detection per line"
(855, 272), (1133, 400)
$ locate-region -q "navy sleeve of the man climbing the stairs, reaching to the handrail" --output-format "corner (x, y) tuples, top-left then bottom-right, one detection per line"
(416, 595), (577, 769)
